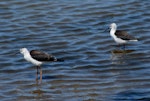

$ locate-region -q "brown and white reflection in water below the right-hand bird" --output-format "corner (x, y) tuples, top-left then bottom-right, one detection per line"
(111, 50), (134, 64)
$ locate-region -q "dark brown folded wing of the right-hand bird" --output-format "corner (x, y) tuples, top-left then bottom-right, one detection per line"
(115, 30), (137, 40)
